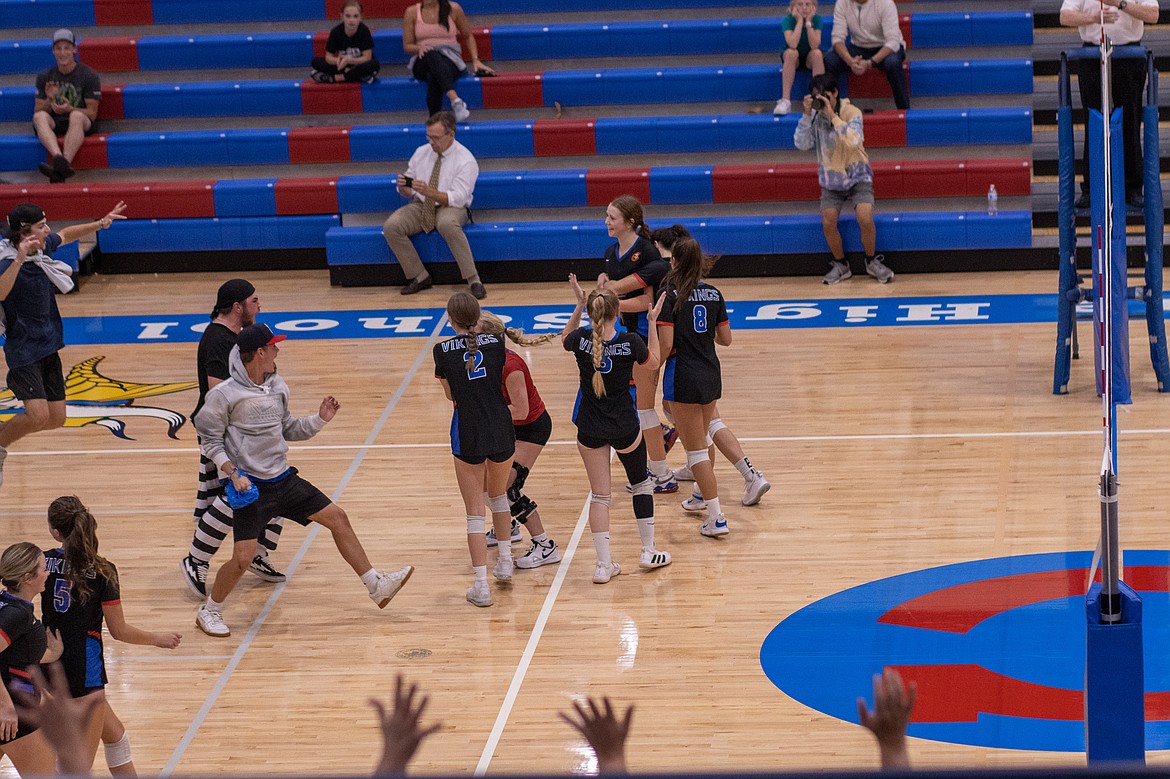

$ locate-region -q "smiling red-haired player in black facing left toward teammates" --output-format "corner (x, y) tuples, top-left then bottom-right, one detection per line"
(598, 195), (679, 495)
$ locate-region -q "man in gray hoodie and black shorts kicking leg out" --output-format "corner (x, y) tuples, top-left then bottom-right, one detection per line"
(194, 323), (414, 637)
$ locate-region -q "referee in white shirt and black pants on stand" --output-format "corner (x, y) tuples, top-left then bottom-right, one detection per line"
(1060, 0), (1158, 211)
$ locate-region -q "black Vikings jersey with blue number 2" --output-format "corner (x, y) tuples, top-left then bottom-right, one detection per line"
(434, 333), (516, 457)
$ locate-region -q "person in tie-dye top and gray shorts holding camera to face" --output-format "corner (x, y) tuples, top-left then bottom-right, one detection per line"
(793, 73), (894, 284)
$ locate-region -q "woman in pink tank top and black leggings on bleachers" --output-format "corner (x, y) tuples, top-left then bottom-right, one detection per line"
(402, 0), (495, 122)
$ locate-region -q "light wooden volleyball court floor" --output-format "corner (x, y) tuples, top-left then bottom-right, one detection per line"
(0, 273), (1170, 775)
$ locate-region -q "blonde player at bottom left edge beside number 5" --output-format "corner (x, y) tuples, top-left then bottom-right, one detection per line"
(0, 542), (61, 777)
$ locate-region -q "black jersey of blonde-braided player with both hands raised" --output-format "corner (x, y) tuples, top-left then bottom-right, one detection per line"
(564, 328), (649, 439)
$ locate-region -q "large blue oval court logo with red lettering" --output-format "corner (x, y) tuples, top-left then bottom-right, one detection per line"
(759, 551), (1170, 752)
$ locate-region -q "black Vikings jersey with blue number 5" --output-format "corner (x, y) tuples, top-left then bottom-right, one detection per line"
(41, 549), (122, 695)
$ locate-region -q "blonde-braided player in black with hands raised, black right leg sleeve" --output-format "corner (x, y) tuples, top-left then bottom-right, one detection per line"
(562, 276), (670, 584)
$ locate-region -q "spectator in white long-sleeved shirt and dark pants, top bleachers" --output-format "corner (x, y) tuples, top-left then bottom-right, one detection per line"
(825, 0), (910, 110)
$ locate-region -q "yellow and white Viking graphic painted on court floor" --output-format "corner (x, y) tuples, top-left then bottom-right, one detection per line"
(0, 354), (199, 441)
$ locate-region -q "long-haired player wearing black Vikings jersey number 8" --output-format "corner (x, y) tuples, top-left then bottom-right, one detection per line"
(658, 237), (731, 537)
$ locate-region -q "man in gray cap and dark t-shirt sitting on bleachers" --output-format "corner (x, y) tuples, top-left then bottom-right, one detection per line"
(33, 29), (102, 184)
